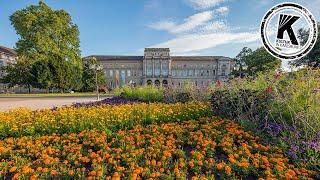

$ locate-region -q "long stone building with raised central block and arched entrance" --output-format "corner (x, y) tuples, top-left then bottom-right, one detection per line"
(84, 48), (234, 89)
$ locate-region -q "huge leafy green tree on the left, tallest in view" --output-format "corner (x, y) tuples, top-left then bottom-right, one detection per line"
(10, 1), (82, 91)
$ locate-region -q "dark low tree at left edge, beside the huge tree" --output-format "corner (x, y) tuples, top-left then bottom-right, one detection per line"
(0, 57), (32, 92)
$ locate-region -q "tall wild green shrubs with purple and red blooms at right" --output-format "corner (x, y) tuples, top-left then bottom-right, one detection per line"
(212, 69), (320, 170)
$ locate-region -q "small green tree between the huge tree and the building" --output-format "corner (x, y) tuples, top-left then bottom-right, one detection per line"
(82, 58), (106, 92)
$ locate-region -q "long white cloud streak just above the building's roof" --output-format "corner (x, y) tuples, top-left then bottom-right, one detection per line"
(151, 32), (260, 54)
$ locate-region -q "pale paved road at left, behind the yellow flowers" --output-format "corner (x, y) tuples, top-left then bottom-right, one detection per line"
(0, 97), (100, 111)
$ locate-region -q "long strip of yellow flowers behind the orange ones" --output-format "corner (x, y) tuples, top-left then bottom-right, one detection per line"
(0, 102), (211, 139)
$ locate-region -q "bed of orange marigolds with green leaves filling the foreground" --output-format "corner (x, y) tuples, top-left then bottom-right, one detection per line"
(0, 118), (314, 179)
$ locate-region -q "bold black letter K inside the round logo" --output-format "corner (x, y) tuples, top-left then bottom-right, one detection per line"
(277, 14), (300, 45)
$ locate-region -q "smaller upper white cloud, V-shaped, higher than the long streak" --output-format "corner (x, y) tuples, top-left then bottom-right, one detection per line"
(149, 11), (213, 34)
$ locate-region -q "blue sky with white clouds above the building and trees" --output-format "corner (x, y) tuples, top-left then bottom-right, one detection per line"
(0, 0), (320, 57)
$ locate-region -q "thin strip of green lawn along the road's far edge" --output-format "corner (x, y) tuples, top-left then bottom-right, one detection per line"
(0, 93), (112, 97)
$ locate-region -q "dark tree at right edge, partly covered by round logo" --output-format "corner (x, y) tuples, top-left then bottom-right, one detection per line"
(291, 23), (320, 67)
